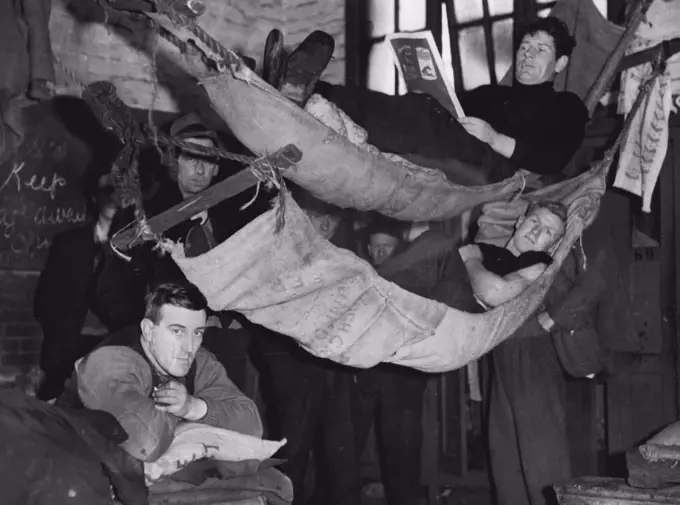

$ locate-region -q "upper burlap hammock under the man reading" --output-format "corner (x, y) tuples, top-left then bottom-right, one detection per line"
(201, 66), (523, 221)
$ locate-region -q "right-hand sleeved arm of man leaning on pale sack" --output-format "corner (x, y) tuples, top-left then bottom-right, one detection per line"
(194, 349), (263, 438)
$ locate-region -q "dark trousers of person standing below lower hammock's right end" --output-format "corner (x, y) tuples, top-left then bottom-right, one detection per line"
(489, 336), (572, 505)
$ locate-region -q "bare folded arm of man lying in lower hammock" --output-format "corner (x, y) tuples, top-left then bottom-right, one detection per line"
(460, 245), (545, 307)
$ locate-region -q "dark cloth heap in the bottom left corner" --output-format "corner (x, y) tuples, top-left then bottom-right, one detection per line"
(0, 390), (148, 505)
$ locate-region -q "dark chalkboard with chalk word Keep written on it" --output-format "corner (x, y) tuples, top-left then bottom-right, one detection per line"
(0, 99), (107, 270)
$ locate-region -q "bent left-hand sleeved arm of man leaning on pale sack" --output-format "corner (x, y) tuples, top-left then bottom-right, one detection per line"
(76, 346), (178, 461)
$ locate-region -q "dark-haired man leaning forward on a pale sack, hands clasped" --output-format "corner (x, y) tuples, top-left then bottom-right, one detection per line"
(58, 284), (262, 461)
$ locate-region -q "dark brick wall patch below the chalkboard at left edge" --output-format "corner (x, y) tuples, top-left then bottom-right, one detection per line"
(0, 270), (42, 369)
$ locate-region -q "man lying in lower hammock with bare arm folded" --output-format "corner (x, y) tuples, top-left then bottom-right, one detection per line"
(459, 202), (567, 307)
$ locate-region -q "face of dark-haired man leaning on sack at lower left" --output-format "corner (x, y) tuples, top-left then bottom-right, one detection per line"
(141, 305), (207, 377)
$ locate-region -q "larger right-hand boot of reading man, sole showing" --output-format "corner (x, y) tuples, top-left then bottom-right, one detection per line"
(281, 30), (335, 107)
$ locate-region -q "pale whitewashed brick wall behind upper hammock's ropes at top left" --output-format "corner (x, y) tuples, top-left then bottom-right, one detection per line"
(50, 0), (345, 112)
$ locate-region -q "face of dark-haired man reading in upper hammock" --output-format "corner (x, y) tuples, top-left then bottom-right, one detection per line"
(515, 32), (569, 86)
